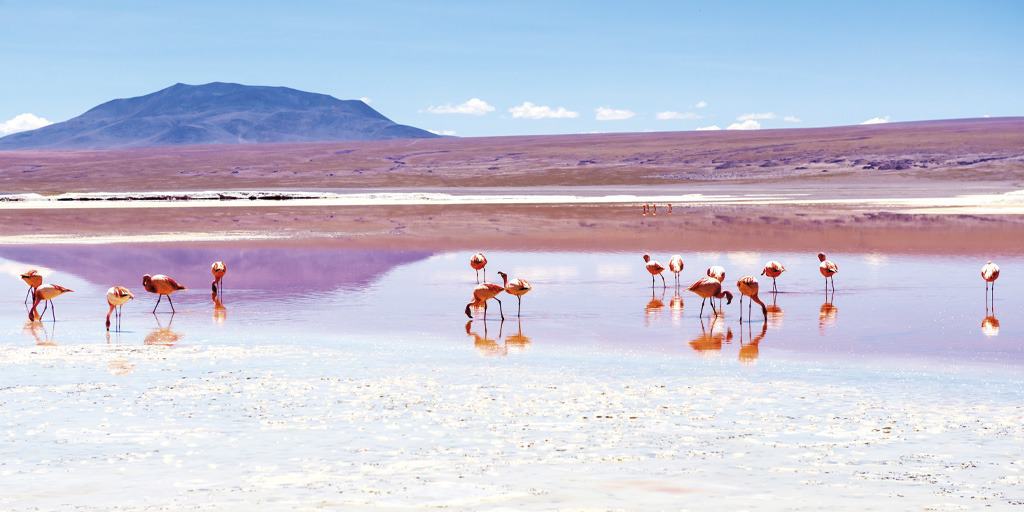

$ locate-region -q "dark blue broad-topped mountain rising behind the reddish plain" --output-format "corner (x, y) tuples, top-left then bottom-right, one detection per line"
(0, 82), (437, 150)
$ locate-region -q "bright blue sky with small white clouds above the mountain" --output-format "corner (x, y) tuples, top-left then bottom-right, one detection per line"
(0, 0), (1024, 136)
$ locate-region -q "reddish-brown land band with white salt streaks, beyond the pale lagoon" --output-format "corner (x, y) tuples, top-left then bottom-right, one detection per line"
(0, 118), (1024, 252)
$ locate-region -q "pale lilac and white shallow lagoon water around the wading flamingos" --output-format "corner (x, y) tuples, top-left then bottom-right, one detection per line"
(0, 244), (1024, 510)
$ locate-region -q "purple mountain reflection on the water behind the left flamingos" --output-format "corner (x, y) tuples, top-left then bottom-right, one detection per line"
(0, 244), (431, 293)
